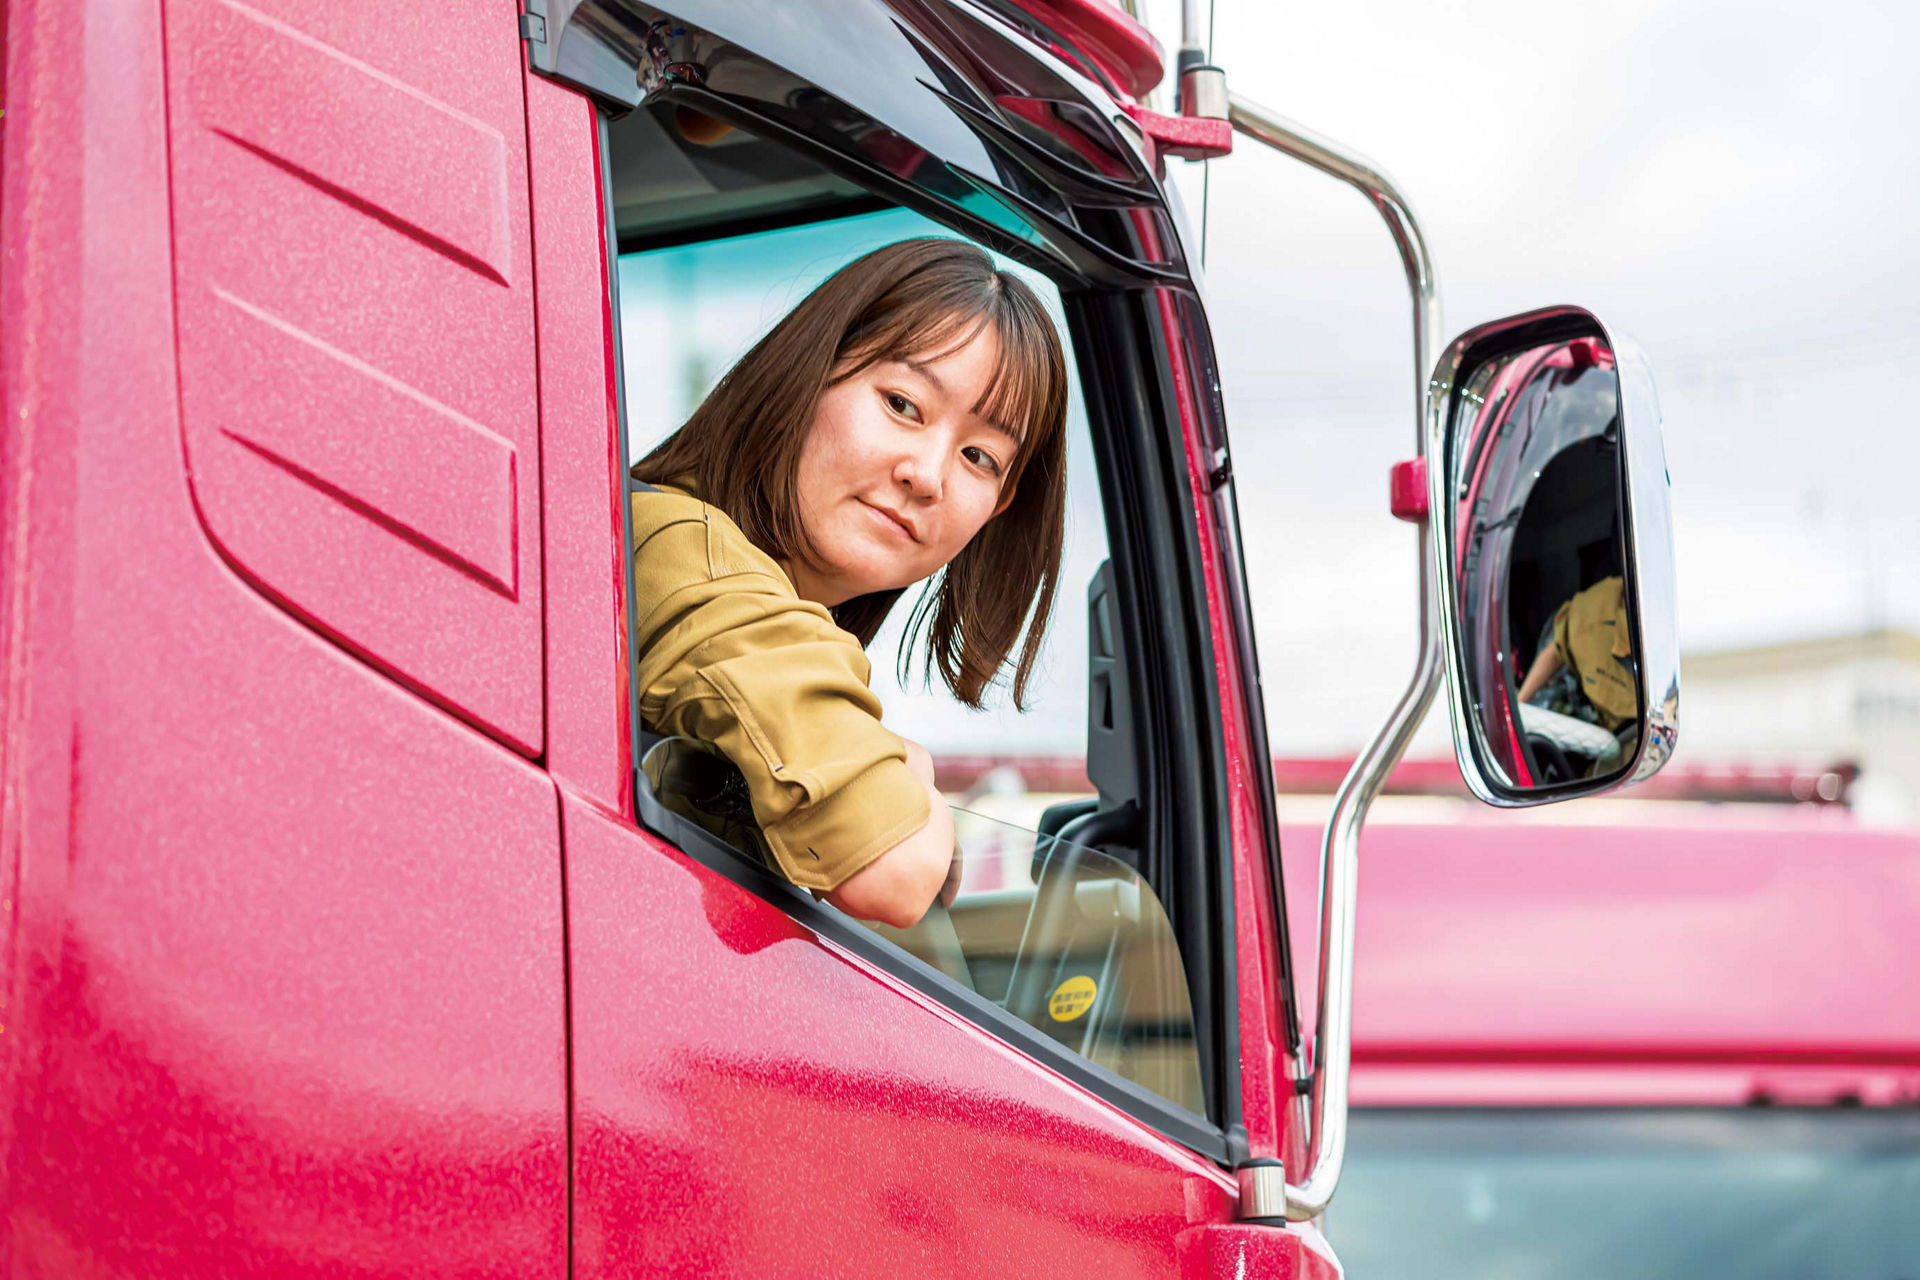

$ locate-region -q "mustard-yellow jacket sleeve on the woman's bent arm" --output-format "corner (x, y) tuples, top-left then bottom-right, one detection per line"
(634, 497), (931, 890)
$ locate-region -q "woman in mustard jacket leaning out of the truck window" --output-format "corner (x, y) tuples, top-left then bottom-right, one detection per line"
(632, 240), (1066, 927)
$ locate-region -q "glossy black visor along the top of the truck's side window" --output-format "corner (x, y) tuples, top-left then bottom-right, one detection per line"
(524, 0), (1194, 292)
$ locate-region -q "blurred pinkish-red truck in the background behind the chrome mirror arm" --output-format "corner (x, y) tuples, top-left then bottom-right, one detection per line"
(1283, 806), (1920, 1280)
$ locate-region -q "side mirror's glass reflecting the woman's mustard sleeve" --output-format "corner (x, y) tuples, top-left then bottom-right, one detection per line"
(1448, 338), (1642, 791)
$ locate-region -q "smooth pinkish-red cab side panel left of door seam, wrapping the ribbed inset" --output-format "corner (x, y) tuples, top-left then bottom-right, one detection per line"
(0, 6), (566, 1278)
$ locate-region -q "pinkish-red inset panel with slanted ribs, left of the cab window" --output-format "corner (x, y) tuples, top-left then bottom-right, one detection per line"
(167, 0), (543, 754)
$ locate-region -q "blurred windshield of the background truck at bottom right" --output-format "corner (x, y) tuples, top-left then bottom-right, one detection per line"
(1327, 1107), (1920, 1280)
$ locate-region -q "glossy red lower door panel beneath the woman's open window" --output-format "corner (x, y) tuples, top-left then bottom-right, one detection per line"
(563, 793), (1233, 1280)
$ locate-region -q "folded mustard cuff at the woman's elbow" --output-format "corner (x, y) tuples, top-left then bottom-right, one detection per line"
(764, 758), (933, 892)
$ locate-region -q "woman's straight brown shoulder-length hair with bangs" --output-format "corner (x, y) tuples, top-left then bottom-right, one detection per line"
(634, 238), (1068, 706)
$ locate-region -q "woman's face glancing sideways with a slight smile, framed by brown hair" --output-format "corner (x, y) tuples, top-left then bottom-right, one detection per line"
(787, 324), (1018, 606)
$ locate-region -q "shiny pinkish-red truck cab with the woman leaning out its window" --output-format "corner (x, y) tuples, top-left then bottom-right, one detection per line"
(0, 0), (1678, 1278)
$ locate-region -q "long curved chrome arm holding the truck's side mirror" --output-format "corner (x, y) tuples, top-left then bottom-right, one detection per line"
(1227, 94), (1440, 1221)
